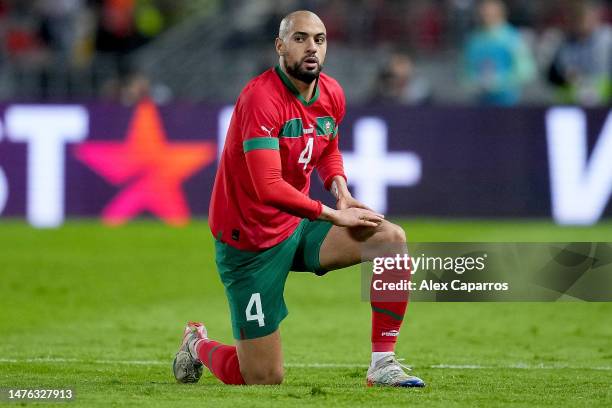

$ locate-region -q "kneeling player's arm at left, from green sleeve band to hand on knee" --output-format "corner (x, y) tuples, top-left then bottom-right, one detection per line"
(245, 146), (384, 227)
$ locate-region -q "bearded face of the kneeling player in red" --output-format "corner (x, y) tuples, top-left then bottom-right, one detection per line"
(277, 16), (327, 84)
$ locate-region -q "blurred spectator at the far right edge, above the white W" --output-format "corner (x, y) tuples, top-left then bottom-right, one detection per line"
(548, 2), (612, 105)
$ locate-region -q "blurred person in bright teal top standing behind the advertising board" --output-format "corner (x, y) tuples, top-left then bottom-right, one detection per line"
(464, 0), (535, 106)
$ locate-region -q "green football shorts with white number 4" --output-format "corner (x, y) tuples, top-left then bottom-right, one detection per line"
(215, 219), (332, 340)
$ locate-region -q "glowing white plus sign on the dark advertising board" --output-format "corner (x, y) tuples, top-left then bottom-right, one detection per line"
(342, 118), (422, 213)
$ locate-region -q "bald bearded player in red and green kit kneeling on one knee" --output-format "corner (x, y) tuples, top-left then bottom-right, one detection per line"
(173, 11), (425, 387)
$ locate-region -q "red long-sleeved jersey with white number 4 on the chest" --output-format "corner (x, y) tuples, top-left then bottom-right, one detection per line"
(209, 66), (346, 251)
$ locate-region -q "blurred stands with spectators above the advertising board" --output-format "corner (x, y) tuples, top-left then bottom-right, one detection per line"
(0, 0), (612, 106)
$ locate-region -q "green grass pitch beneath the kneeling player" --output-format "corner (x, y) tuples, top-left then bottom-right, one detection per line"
(0, 220), (612, 407)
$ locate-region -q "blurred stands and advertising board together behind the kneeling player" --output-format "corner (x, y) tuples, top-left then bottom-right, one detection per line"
(0, 0), (612, 226)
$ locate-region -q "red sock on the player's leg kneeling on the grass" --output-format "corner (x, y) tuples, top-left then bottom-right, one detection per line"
(196, 340), (245, 385)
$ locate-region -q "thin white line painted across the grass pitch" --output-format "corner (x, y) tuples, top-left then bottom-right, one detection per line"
(0, 357), (612, 371)
